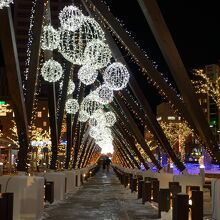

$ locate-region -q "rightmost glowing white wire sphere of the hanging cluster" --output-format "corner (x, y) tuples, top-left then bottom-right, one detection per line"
(103, 62), (130, 91)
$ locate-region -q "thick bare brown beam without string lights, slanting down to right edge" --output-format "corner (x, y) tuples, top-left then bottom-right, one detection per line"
(138, 0), (220, 162)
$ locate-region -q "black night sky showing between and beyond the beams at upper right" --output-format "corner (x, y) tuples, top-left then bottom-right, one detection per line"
(105, 0), (220, 108)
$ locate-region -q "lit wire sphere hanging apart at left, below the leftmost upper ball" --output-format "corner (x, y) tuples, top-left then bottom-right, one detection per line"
(41, 59), (63, 82)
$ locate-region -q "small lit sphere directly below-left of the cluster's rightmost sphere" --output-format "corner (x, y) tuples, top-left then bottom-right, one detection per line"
(96, 84), (114, 105)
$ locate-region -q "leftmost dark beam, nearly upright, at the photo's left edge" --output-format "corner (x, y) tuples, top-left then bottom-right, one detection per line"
(0, 8), (30, 171)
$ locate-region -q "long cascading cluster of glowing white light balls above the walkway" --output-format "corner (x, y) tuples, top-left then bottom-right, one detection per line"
(42, 5), (129, 154)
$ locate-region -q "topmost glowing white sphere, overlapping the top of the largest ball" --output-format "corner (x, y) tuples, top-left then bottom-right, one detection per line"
(59, 5), (84, 31)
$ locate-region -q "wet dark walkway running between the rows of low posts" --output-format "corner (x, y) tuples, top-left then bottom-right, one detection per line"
(43, 170), (157, 220)
